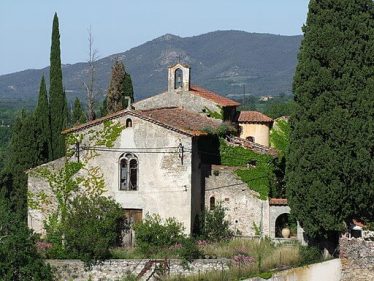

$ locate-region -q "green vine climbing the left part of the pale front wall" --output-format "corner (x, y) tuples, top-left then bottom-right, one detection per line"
(28, 117), (124, 249)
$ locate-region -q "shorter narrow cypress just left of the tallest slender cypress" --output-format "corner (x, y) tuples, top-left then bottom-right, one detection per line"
(34, 75), (52, 164)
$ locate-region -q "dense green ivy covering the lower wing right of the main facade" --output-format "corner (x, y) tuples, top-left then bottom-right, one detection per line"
(220, 139), (274, 200)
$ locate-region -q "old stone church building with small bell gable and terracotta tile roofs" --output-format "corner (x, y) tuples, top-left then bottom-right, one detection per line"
(28, 64), (302, 242)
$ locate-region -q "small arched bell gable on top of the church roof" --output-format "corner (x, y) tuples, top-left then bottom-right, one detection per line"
(168, 63), (190, 92)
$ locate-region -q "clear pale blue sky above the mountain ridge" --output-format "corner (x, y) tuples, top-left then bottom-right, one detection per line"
(0, 0), (309, 75)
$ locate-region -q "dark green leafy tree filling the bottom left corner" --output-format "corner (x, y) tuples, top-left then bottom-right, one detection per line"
(0, 195), (53, 281)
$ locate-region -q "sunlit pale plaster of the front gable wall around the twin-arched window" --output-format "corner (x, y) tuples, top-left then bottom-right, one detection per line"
(29, 116), (201, 233)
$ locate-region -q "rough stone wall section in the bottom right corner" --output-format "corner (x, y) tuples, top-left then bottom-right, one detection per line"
(339, 237), (374, 281)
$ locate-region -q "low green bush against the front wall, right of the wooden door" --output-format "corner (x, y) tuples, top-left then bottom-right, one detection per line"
(134, 214), (184, 254)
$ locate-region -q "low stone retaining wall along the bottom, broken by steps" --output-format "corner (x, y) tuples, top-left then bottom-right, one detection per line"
(47, 259), (230, 281)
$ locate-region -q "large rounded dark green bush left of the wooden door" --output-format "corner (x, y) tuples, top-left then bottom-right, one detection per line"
(64, 196), (123, 266)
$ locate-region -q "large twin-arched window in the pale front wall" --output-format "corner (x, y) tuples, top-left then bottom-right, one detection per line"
(119, 153), (139, 190)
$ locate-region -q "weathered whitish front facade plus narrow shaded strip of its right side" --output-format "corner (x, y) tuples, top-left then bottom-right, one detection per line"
(28, 107), (213, 234)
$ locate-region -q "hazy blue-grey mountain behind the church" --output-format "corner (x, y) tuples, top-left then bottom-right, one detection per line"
(0, 30), (302, 104)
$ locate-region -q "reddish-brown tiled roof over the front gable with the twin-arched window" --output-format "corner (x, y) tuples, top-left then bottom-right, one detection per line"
(62, 107), (221, 136)
